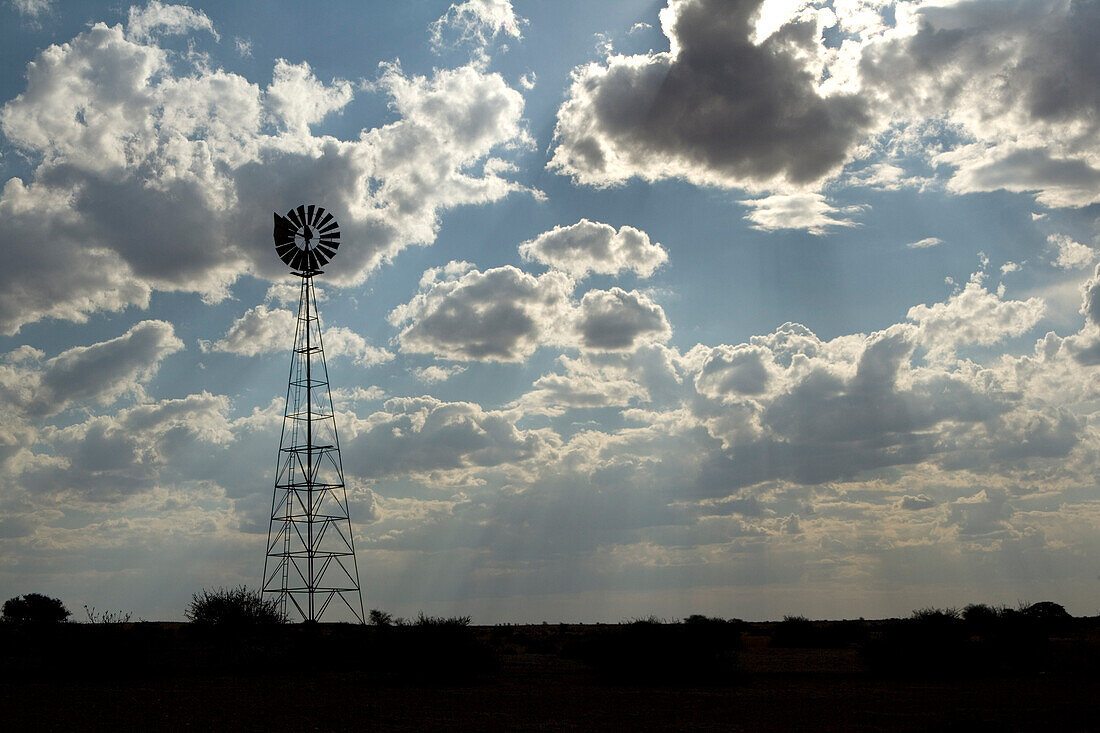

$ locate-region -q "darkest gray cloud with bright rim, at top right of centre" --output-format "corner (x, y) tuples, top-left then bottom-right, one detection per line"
(550, 0), (871, 187)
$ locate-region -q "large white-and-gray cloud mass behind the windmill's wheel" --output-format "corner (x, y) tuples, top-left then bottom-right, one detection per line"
(0, 19), (529, 333)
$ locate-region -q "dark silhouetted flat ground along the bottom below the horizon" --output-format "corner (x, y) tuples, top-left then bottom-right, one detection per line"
(0, 619), (1100, 731)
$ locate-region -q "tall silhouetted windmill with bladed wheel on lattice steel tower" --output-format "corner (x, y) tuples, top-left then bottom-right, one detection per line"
(263, 205), (363, 623)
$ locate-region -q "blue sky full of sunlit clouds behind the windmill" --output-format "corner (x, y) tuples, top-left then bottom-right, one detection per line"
(0, 0), (1100, 623)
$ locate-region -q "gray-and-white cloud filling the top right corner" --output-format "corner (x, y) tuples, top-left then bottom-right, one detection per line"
(859, 0), (1100, 206)
